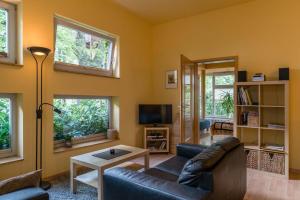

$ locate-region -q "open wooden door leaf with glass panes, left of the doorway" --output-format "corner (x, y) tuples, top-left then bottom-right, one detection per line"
(180, 55), (199, 144)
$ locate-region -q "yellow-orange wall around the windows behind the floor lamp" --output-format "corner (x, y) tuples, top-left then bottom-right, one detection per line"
(0, 0), (151, 179)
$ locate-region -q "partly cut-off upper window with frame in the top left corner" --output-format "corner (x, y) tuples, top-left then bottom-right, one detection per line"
(0, 1), (16, 63)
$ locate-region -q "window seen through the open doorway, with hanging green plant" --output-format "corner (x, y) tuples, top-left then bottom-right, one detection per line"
(205, 72), (234, 118)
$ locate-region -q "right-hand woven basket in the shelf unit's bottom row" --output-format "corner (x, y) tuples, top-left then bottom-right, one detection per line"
(261, 152), (284, 174)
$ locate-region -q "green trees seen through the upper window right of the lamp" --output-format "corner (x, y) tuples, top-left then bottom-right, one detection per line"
(55, 25), (112, 70)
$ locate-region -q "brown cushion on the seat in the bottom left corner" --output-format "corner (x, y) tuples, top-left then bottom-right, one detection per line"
(0, 170), (42, 195)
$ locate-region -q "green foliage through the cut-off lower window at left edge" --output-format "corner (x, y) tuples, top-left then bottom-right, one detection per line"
(0, 98), (10, 150)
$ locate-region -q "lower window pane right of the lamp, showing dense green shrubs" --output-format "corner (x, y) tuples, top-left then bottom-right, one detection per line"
(53, 96), (111, 146)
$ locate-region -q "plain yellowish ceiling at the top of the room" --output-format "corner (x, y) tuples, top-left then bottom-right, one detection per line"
(111, 0), (251, 24)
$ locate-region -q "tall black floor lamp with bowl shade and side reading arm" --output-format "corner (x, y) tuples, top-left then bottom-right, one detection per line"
(28, 47), (61, 190)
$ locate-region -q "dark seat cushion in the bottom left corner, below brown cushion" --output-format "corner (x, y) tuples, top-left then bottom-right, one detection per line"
(0, 187), (49, 200)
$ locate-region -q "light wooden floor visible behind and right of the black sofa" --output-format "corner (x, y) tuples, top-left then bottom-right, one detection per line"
(141, 154), (300, 200)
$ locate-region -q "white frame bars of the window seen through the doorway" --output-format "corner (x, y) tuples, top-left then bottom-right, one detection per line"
(206, 72), (235, 120)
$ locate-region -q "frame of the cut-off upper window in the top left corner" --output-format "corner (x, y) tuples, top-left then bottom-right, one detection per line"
(0, 1), (17, 63)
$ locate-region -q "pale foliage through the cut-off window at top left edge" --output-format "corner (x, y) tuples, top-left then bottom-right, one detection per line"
(0, 9), (8, 55)
